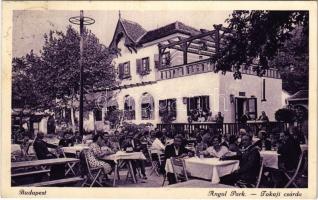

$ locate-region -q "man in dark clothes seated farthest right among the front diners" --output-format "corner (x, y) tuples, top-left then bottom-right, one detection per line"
(277, 131), (301, 170)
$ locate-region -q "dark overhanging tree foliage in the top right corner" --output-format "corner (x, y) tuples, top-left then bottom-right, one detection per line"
(216, 10), (309, 83)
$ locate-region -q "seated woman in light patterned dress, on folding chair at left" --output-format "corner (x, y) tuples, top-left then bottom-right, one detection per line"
(87, 133), (114, 174)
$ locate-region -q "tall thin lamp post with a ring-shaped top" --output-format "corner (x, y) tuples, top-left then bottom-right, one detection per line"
(69, 10), (95, 135)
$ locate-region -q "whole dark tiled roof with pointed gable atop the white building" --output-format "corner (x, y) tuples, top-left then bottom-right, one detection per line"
(109, 18), (201, 48)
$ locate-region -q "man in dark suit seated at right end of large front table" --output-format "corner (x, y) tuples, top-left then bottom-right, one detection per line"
(220, 135), (260, 185)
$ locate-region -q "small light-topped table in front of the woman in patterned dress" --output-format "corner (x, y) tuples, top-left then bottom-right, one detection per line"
(102, 151), (146, 186)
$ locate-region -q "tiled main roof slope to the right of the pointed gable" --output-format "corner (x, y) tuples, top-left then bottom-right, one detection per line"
(139, 21), (201, 44)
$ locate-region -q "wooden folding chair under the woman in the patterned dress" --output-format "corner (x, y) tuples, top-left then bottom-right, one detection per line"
(80, 149), (106, 187)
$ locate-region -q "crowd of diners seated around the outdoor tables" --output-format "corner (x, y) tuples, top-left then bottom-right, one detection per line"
(11, 125), (302, 186)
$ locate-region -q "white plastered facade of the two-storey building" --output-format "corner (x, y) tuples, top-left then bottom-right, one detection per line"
(85, 18), (282, 126)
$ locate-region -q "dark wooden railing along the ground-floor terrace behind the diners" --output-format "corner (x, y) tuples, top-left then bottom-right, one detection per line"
(157, 122), (288, 135)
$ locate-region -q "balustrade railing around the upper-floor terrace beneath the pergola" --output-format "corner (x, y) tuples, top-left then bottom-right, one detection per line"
(157, 59), (281, 80)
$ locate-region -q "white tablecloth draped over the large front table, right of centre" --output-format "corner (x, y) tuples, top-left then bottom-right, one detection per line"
(165, 157), (239, 184)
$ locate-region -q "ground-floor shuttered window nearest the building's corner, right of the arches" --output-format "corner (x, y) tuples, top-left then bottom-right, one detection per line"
(187, 96), (210, 121)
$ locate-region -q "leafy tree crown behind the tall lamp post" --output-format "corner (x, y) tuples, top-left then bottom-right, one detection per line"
(12, 26), (115, 109)
